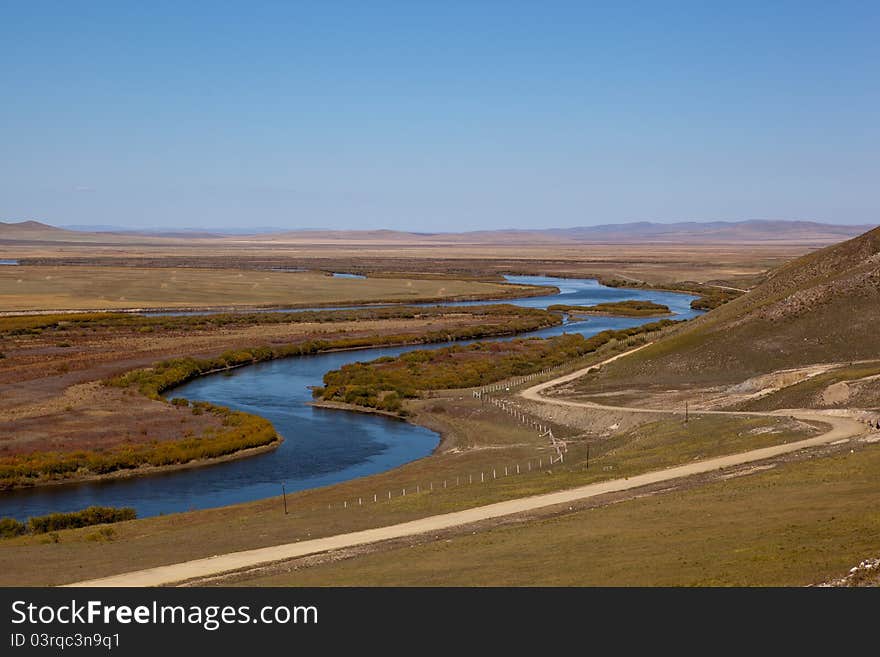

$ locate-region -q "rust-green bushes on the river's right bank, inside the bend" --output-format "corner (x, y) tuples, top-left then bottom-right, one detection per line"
(313, 320), (676, 413)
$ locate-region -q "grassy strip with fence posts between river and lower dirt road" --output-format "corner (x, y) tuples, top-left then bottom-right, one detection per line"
(0, 391), (820, 585)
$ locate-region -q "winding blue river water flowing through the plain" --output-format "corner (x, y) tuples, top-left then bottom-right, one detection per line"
(0, 276), (699, 519)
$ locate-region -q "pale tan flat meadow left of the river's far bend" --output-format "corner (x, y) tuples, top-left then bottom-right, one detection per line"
(0, 266), (547, 312)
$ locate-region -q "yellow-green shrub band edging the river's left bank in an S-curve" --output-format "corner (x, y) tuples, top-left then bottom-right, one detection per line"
(0, 304), (562, 489)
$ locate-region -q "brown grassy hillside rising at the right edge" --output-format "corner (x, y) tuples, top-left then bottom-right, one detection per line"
(584, 228), (880, 390)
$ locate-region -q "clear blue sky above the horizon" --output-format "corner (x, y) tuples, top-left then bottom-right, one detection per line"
(0, 0), (880, 231)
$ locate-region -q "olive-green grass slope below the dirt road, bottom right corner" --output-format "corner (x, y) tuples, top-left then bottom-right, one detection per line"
(229, 438), (880, 586)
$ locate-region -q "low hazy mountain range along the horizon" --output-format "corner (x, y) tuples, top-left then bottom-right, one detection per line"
(0, 220), (873, 245)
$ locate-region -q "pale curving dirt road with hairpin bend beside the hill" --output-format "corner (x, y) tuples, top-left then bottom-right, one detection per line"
(68, 344), (865, 586)
